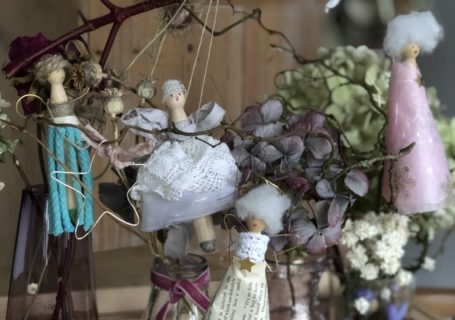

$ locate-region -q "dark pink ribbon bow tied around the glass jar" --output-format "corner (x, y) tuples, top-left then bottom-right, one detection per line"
(151, 267), (210, 320)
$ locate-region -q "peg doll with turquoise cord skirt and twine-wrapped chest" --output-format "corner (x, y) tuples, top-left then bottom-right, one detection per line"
(35, 55), (93, 235)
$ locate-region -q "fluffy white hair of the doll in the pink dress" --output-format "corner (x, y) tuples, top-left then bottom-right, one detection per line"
(384, 11), (444, 58)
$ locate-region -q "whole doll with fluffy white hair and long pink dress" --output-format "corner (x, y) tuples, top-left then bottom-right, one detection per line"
(382, 12), (451, 214)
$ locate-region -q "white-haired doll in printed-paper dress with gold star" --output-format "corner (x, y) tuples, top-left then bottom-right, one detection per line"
(206, 184), (291, 320)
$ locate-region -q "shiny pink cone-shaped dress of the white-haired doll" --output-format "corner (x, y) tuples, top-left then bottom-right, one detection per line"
(382, 62), (451, 214)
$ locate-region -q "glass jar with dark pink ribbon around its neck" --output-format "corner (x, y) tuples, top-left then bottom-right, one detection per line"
(142, 255), (210, 320)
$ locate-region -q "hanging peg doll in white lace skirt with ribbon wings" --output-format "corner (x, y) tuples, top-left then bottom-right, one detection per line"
(122, 80), (237, 252)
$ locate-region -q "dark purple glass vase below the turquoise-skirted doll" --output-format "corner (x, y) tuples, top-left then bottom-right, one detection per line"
(6, 186), (98, 320)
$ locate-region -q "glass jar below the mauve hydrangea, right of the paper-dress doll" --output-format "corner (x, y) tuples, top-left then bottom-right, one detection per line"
(267, 256), (331, 320)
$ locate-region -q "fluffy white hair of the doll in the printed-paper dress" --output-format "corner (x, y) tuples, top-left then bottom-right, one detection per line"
(235, 184), (291, 234)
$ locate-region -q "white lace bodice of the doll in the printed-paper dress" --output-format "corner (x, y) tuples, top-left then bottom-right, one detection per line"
(234, 232), (270, 263)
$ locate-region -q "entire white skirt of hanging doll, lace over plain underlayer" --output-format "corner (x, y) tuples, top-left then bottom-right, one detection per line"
(131, 136), (238, 231)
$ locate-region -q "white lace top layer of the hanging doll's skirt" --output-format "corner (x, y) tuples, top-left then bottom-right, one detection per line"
(131, 136), (237, 200)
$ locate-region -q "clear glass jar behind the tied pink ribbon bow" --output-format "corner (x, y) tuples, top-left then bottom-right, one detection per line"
(142, 255), (210, 320)
